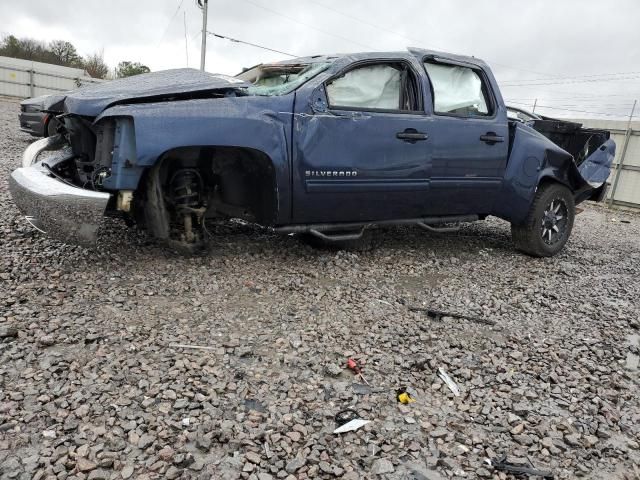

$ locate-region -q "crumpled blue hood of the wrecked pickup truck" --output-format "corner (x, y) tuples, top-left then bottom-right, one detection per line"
(44, 68), (250, 117)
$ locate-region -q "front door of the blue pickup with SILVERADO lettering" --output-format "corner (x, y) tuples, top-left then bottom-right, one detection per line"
(292, 59), (431, 223)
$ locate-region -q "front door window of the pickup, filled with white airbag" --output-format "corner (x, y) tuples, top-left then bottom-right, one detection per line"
(326, 63), (418, 111)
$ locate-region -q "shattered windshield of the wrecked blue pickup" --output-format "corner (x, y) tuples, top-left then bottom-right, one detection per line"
(236, 62), (330, 95)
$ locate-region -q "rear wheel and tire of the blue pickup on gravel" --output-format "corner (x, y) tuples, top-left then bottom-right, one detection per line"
(511, 183), (575, 257)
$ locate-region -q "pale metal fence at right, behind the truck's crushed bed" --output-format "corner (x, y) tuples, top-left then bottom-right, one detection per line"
(577, 119), (640, 209)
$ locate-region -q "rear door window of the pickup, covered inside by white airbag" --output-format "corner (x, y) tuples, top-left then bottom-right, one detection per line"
(424, 62), (493, 117)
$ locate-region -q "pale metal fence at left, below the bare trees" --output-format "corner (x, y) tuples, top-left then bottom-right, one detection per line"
(0, 58), (103, 98)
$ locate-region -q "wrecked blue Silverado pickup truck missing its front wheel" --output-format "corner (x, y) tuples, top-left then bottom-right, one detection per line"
(10, 49), (615, 256)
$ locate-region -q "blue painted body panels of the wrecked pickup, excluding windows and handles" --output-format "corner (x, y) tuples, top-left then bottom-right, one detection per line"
(57, 49), (615, 225)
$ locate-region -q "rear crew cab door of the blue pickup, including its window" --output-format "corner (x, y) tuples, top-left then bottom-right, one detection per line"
(423, 57), (509, 215)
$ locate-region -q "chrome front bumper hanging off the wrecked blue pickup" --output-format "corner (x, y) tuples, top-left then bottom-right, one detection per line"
(9, 138), (111, 246)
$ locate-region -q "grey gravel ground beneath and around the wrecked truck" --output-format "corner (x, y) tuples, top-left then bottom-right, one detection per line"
(0, 94), (640, 480)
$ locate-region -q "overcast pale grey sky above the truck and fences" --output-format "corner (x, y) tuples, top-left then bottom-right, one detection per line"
(0, 0), (640, 118)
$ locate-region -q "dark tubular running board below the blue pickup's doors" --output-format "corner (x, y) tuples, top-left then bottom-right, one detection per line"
(274, 215), (480, 241)
